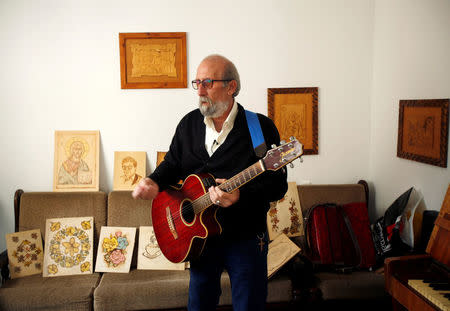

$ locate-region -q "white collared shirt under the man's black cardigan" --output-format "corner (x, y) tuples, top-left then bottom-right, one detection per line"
(203, 100), (238, 156)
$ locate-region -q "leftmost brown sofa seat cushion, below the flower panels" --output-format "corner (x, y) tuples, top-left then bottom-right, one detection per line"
(0, 273), (100, 311)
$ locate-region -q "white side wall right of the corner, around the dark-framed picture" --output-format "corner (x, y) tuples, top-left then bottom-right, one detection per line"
(369, 0), (450, 215)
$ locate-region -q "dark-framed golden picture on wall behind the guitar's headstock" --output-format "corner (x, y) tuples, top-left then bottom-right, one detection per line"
(267, 87), (319, 155)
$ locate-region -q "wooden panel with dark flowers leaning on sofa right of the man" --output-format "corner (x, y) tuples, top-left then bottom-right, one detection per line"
(267, 182), (304, 241)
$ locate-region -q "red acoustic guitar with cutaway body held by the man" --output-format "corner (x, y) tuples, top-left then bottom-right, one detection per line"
(152, 137), (303, 263)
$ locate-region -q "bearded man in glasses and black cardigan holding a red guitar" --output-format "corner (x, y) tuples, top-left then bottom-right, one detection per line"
(132, 55), (293, 311)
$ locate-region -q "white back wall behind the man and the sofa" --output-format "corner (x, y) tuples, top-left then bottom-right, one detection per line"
(0, 0), (428, 254)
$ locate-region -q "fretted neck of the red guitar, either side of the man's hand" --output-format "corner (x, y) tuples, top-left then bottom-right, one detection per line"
(192, 160), (265, 214)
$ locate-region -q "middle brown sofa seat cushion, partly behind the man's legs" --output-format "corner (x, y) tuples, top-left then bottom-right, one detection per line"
(94, 269), (292, 310)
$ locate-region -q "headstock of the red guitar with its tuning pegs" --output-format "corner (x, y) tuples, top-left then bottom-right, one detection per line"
(262, 137), (303, 171)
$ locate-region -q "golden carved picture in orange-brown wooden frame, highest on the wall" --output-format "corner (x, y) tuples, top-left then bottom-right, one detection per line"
(119, 32), (187, 89)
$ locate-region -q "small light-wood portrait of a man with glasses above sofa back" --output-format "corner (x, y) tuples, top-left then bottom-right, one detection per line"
(113, 151), (147, 190)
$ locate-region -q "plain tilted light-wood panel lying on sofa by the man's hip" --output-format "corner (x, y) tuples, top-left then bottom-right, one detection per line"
(267, 234), (300, 278)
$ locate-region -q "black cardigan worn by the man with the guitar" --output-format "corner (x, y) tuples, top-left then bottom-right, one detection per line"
(149, 104), (287, 239)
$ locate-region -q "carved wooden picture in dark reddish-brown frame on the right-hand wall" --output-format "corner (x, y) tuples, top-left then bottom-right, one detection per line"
(397, 98), (450, 167)
